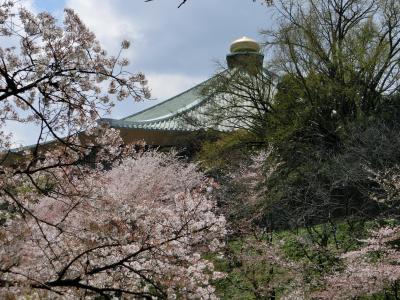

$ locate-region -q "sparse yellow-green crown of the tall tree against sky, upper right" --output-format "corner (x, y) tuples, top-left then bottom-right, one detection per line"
(264, 0), (400, 144)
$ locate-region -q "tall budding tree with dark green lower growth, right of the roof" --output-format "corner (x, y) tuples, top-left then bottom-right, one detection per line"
(253, 0), (400, 230)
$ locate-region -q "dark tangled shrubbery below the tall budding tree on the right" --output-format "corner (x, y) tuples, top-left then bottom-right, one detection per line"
(265, 105), (400, 227)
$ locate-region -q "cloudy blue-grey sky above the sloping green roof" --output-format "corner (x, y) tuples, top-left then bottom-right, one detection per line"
(7, 0), (272, 145)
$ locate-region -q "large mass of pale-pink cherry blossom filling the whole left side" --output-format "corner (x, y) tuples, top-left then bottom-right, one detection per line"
(0, 1), (225, 299)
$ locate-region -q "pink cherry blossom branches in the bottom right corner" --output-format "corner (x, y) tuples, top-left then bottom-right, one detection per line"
(312, 226), (400, 299)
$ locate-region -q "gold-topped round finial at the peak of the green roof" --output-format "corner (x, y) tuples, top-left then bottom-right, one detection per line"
(226, 36), (264, 72)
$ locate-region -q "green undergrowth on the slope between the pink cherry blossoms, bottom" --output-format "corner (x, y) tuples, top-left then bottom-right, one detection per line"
(209, 219), (399, 300)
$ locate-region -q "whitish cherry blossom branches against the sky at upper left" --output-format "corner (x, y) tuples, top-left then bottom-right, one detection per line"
(0, 1), (150, 202)
